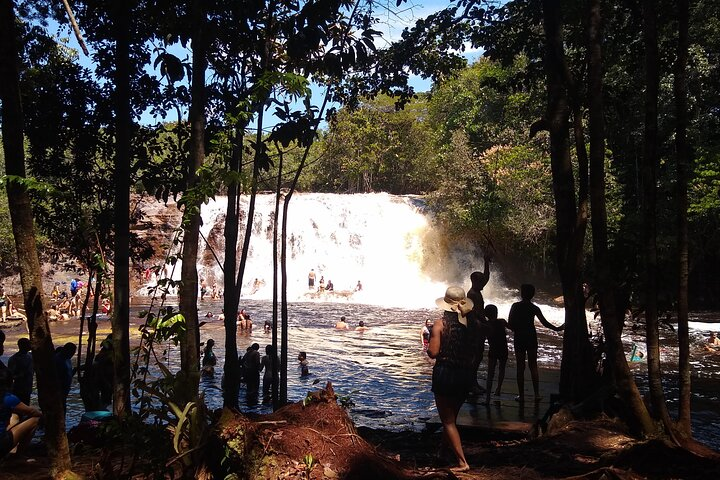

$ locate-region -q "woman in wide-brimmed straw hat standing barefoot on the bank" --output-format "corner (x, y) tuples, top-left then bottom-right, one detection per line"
(428, 287), (479, 472)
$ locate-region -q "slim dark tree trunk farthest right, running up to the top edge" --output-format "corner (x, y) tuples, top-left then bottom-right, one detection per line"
(674, 0), (692, 438)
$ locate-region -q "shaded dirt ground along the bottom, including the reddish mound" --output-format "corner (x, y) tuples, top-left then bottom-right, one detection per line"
(0, 387), (720, 480)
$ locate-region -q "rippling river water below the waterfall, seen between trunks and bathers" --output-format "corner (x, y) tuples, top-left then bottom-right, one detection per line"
(6, 300), (720, 448)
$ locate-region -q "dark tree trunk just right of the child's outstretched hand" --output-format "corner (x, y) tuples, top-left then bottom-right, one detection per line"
(543, 0), (592, 401)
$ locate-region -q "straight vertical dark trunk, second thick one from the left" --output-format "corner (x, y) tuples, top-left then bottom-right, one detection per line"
(112, 2), (132, 417)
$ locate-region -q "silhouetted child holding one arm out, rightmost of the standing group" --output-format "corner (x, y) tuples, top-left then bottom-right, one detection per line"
(508, 284), (565, 402)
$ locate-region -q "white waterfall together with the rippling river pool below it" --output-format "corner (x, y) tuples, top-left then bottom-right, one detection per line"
(115, 193), (720, 445)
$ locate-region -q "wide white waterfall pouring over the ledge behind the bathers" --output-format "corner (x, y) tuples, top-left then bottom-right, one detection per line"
(139, 193), (508, 308)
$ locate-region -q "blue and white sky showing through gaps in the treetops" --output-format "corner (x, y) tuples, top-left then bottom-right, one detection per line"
(51, 0), (480, 125)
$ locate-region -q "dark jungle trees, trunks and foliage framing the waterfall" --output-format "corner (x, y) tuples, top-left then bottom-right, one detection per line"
(0, 0), (720, 476)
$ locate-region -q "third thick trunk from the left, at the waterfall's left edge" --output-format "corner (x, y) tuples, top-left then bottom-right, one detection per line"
(178, 0), (207, 404)
